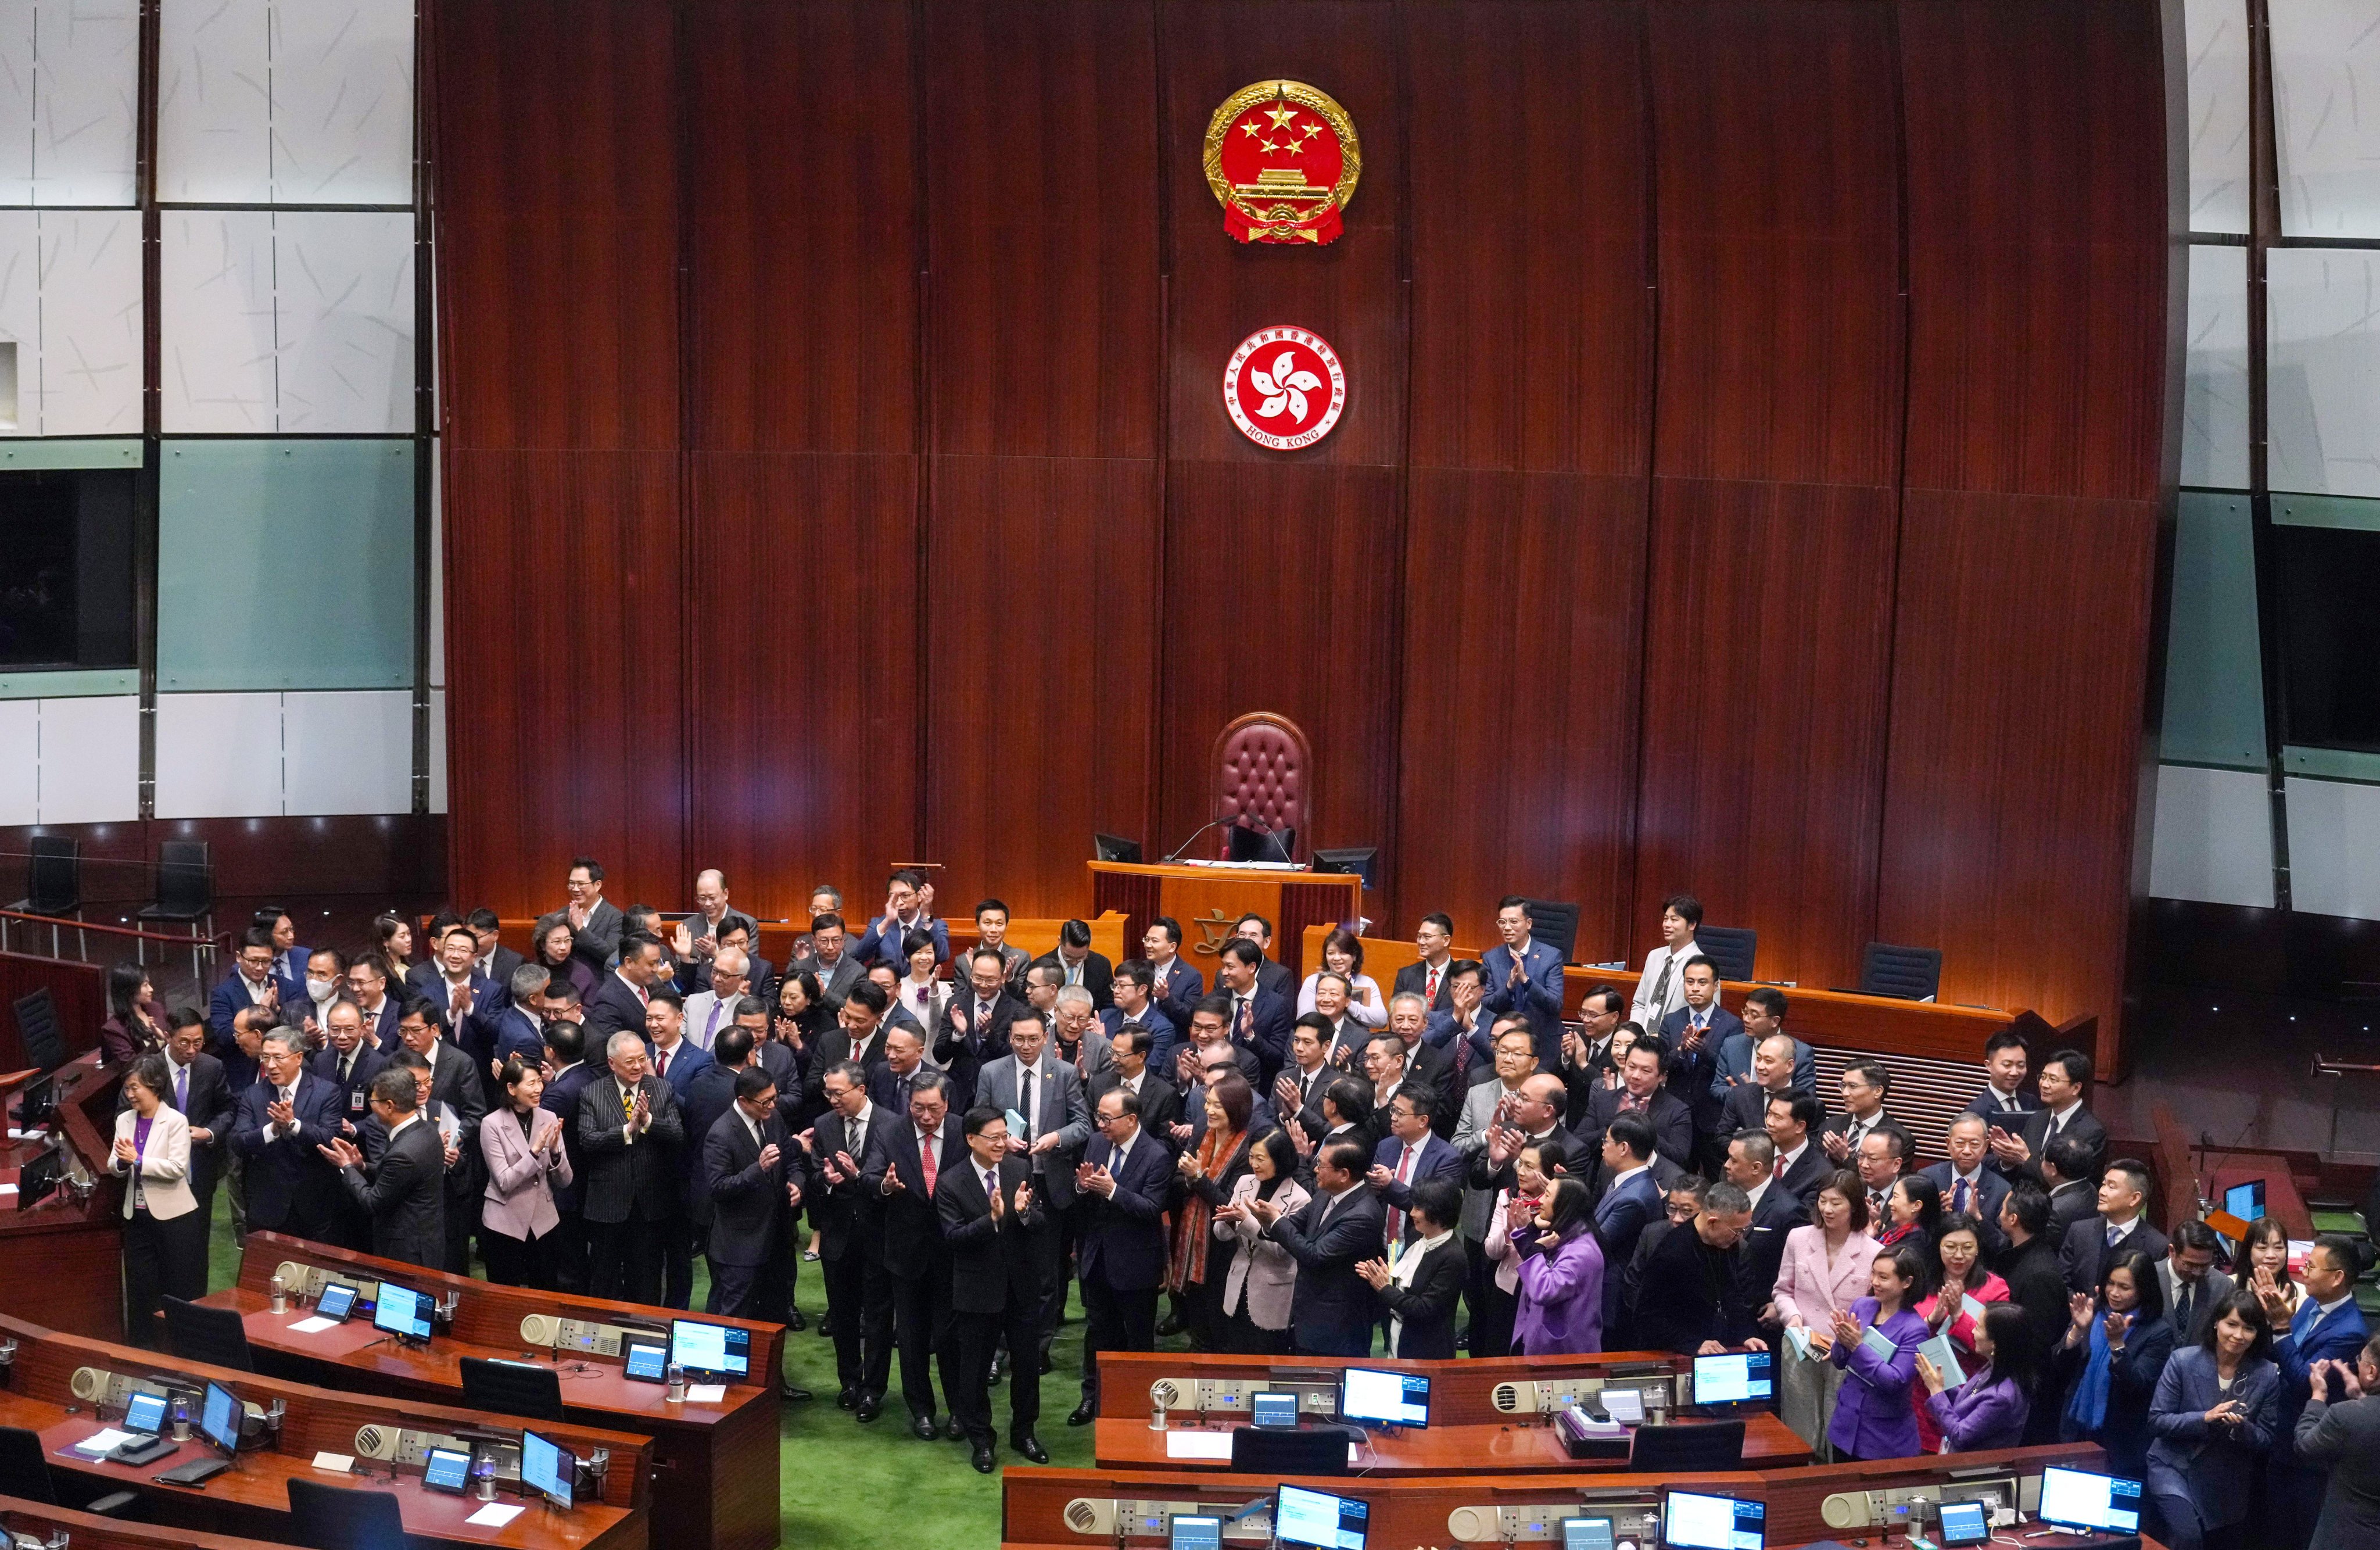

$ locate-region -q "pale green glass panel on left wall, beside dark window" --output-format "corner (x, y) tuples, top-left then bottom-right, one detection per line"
(157, 441), (414, 690)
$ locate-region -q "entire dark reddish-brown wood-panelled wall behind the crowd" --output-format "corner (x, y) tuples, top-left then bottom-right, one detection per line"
(428, 0), (2182, 1062)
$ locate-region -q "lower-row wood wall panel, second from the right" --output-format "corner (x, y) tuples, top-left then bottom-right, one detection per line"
(1628, 478), (1894, 1005)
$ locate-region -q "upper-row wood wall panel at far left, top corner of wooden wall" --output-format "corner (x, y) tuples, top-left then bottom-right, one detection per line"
(428, 0), (678, 454)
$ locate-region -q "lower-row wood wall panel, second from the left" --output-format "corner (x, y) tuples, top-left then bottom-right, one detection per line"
(690, 452), (919, 917)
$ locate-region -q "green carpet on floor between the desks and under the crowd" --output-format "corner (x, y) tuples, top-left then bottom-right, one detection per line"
(209, 1214), (1092, 1550)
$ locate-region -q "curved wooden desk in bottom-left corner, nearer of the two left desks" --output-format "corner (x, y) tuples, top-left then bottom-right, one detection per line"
(0, 1317), (652, 1550)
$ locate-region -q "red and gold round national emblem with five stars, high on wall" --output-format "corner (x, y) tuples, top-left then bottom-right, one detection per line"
(1207, 81), (1364, 243)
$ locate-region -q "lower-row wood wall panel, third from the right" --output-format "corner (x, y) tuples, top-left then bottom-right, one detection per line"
(1383, 469), (1644, 962)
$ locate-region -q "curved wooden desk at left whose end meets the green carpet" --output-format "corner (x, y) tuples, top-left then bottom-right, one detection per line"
(205, 1233), (786, 1550)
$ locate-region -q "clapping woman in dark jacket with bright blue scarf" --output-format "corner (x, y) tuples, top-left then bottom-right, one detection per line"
(2042, 1248), (2173, 1481)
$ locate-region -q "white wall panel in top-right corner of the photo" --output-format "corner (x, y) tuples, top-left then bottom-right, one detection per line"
(2273, 0), (2380, 236)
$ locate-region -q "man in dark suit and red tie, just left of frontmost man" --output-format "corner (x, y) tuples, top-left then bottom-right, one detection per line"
(862, 1080), (966, 1443)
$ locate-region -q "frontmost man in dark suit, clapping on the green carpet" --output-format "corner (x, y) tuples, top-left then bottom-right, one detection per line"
(933, 1107), (1049, 1474)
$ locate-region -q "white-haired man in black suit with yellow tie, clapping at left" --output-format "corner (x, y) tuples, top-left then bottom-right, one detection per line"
(578, 1029), (686, 1302)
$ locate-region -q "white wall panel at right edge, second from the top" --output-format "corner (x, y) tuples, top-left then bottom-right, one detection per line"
(2263, 248), (2380, 495)
